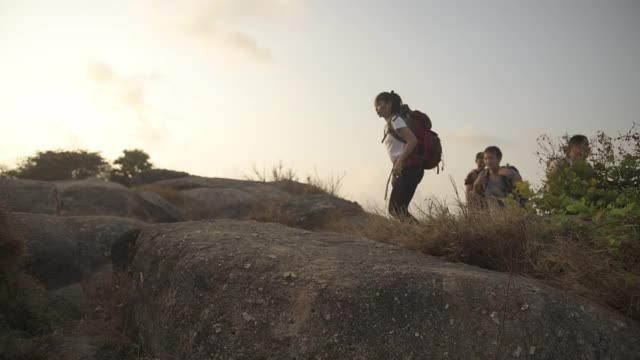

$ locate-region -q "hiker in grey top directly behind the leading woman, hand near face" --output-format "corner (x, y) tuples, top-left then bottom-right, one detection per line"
(473, 146), (522, 206)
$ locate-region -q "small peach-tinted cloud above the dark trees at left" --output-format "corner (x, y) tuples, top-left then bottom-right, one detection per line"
(87, 61), (165, 142)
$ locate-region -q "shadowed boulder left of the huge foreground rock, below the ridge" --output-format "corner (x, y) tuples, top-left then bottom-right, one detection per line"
(12, 213), (143, 289)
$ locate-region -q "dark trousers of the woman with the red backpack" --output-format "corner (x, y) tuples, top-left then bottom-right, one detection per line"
(389, 167), (424, 222)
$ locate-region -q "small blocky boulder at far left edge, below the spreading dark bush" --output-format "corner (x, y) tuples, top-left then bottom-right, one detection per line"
(0, 178), (60, 215)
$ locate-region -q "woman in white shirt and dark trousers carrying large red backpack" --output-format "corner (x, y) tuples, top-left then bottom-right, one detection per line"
(375, 91), (442, 222)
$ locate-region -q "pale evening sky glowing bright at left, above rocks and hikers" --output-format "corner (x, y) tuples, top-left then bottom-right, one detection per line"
(0, 0), (640, 207)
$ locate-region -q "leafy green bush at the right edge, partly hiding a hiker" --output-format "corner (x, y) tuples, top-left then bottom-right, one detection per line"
(520, 124), (640, 262)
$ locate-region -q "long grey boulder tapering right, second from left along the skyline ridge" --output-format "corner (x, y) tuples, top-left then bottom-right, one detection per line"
(56, 179), (180, 222)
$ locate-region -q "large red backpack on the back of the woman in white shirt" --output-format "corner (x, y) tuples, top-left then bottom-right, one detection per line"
(382, 105), (442, 173)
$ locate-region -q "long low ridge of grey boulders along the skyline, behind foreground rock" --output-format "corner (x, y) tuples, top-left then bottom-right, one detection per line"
(0, 173), (364, 229)
